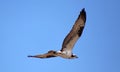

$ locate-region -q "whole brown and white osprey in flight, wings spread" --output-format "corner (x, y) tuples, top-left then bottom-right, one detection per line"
(28, 8), (86, 59)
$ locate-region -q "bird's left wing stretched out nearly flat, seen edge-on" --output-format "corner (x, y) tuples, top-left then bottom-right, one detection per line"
(28, 50), (56, 58)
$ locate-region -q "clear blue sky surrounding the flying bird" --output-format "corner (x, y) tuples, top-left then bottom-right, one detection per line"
(0, 0), (120, 72)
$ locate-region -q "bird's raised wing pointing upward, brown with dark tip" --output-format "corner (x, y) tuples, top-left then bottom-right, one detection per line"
(61, 8), (86, 52)
